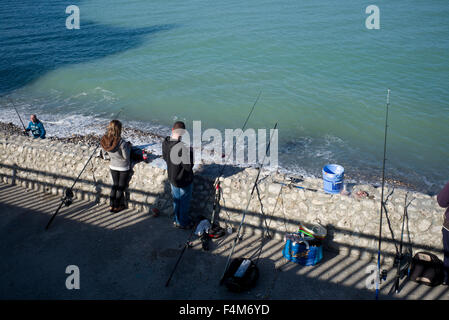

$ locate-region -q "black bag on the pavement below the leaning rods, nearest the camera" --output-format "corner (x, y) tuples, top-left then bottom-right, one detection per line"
(223, 258), (259, 292)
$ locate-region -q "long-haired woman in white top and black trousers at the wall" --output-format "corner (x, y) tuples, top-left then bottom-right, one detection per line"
(100, 120), (131, 212)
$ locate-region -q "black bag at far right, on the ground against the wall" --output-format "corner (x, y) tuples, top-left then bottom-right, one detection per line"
(410, 252), (444, 287)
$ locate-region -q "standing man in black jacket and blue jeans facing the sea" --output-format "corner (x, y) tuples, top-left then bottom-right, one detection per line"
(162, 121), (193, 229)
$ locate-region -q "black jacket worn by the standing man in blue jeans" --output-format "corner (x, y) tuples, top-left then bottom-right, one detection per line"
(162, 137), (193, 188)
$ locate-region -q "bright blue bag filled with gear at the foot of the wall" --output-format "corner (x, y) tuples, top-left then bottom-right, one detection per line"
(282, 232), (323, 266)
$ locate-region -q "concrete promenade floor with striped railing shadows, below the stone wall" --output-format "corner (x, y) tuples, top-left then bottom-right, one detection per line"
(0, 183), (449, 300)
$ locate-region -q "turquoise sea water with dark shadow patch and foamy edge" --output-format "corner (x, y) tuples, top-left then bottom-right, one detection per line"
(0, 0), (449, 192)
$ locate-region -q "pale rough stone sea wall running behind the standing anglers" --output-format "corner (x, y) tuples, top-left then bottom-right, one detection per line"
(0, 135), (444, 261)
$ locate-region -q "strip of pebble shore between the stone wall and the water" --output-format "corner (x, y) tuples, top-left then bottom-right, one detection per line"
(0, 121), (428, 196)
